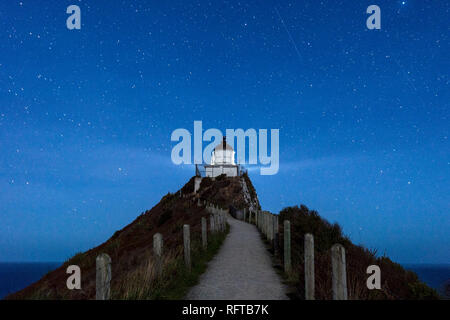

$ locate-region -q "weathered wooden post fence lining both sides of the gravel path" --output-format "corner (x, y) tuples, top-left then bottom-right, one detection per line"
(96, 205), (348, 300)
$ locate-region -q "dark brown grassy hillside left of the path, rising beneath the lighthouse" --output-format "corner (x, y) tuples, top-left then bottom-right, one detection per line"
(6, 177), (259, 299)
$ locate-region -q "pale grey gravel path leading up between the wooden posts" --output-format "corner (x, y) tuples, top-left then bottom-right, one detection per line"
(186, 216), (288, 300)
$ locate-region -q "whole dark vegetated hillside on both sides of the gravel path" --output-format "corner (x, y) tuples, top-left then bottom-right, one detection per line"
(6, 174), (438, 300)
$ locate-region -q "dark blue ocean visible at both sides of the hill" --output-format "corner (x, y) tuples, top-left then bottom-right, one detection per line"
(0, 262), (450, 299)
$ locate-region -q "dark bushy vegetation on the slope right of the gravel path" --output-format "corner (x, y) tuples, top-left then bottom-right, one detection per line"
(278, 205), (439, 300)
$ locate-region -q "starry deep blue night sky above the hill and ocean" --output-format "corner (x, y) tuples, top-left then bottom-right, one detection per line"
(0, 0), (450, 263)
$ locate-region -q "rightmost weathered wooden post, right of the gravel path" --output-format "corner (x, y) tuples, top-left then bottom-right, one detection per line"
(331, 243), (347, 300)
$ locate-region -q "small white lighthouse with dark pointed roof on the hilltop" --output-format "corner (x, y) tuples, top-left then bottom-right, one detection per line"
(204, 137), (239, 178)
